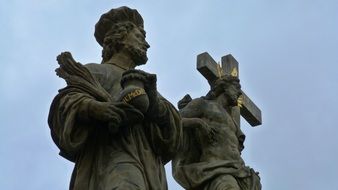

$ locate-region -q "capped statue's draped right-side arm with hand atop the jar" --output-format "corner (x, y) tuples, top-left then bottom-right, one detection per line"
(123, 70), (183, 163)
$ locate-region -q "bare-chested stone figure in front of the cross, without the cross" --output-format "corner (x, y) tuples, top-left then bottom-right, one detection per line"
(173, 76), (261, 190)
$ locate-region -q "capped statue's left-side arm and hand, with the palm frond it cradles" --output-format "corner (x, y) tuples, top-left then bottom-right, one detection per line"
(48, 53), (139, 159)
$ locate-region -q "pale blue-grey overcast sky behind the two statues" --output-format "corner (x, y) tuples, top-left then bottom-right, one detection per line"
(0, 0), (338, 190)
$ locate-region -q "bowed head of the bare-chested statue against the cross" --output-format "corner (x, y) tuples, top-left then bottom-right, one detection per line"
(206, 76), (242, 106)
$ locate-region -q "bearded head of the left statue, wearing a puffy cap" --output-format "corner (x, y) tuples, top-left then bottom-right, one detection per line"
(94, 7), (150, 65)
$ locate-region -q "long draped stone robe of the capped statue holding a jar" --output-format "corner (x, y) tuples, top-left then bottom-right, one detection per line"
(48, 63), (181, 190)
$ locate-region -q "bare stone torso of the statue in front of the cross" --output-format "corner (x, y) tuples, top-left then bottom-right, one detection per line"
(180, 98), (244, 163)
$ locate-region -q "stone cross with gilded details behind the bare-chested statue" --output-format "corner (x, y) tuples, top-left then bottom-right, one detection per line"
(197, 52), (262, 127)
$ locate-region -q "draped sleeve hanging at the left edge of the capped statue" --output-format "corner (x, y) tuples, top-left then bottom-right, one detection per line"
(48, 89), (93, 161)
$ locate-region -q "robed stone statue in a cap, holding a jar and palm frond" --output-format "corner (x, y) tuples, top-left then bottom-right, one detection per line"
(48, 7), (182, 190)
